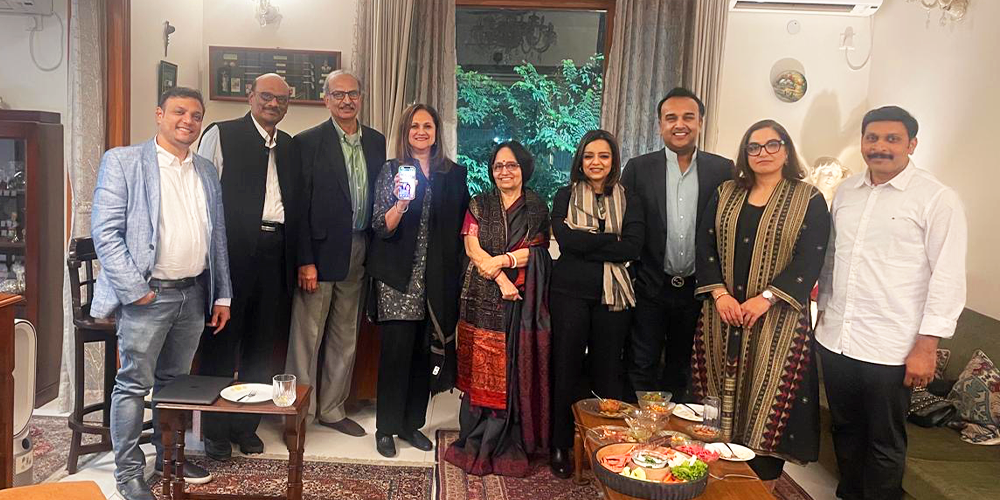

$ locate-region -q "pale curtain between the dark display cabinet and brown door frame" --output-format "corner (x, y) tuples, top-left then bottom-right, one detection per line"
(59, 0), (105, 411)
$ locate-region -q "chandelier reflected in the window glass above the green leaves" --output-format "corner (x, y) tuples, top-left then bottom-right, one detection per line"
(472, 11), (557, 63)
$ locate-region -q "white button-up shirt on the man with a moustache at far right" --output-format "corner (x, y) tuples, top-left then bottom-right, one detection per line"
(816, 161), (968, 365)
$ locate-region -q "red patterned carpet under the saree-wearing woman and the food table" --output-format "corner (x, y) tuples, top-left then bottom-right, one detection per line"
(437, 430), (812, 500)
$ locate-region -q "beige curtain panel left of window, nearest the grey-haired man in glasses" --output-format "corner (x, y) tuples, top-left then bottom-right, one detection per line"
(352, 0), (415, 158)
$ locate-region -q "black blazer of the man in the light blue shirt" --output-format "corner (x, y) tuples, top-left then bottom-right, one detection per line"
(622, 149), (733, 297)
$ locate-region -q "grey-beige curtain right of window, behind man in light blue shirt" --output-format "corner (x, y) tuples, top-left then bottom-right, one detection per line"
(601, 0), (728, 161)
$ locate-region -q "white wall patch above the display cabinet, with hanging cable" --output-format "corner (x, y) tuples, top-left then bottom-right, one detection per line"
(0, 0), (69, 121)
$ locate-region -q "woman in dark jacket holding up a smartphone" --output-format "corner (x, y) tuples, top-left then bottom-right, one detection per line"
(367, 104), (469, 457)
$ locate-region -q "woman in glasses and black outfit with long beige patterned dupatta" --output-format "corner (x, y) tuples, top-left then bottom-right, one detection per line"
(691, 120), (830, 481)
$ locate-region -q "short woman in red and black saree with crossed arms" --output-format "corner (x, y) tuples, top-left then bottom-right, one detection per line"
(445, 141), (552, 477)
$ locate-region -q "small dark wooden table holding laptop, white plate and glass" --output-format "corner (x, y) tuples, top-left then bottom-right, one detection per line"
(156, 384), (312, 500)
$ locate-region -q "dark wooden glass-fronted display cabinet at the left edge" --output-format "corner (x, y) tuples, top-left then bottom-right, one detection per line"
(0, 110), (66, 407)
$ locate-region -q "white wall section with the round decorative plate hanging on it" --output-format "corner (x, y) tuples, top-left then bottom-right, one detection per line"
(706, 12), (871, 171)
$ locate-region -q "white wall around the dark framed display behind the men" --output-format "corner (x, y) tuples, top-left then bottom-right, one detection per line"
(132, 0), (357, 142)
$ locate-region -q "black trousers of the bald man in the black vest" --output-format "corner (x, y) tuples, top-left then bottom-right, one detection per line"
(198, 229), (292, 441)
